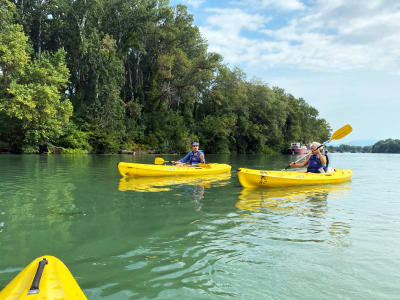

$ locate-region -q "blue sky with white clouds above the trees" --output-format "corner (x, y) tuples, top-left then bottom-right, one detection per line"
(170, 0), (400, 144)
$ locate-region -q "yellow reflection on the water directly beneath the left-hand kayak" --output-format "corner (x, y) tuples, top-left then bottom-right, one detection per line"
(118, 173), (231, 192)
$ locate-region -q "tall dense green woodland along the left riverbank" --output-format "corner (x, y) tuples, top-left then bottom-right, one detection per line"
(0, 0), (331, 153)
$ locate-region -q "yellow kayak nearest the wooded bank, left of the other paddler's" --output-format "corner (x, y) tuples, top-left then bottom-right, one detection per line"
(118, 162), (231, 177)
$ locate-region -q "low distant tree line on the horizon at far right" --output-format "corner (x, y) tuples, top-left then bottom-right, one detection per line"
(328, 139), (400, 153)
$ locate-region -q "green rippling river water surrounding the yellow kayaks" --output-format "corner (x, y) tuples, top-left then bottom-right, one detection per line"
(0, 153), (400, 299)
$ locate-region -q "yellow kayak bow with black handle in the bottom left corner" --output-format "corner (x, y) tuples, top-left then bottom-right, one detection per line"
(0, 255), (87, 300)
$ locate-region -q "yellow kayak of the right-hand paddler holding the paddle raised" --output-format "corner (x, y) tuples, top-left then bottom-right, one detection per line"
(238, 168), (353, 188)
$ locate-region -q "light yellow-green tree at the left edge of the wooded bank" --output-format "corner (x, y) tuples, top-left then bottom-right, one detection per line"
(0, 0), (72, 152)
